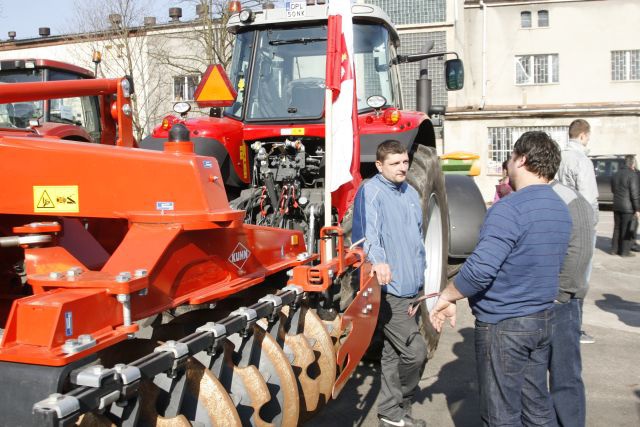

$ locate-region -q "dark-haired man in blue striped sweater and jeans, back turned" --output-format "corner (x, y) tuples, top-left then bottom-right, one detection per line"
(430, 132), (572, 426)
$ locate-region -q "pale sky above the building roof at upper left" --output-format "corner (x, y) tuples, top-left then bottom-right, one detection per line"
(0, 0), (195, 41)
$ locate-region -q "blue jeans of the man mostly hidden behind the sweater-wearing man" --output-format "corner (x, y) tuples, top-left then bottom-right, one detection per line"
(549, 299), (586, 427)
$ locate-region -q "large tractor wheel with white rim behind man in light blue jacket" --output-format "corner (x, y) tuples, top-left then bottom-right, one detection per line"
(407, 145), (449, 358)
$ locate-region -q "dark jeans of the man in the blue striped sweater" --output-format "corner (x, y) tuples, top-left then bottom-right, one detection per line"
(475, 309), (557, 426)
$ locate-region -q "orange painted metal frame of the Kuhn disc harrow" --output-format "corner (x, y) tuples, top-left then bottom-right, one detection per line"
(0, 79), (379, 369)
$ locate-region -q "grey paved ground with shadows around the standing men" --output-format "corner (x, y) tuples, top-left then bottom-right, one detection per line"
(306, 211), (640, 427)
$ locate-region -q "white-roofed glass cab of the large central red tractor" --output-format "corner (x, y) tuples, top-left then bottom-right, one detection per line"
(224, 5), (402, 122)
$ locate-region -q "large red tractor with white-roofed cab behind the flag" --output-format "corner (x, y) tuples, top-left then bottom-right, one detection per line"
(141, 2), (486, 349)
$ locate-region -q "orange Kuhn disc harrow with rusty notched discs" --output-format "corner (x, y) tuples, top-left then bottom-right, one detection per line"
(0, 78), (380, 426)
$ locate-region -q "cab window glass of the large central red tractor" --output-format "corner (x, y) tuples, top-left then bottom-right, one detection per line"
(226, 24), (397, 121)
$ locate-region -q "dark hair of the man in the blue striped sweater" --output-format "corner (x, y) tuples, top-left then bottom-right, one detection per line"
(513, 131), (561, 181)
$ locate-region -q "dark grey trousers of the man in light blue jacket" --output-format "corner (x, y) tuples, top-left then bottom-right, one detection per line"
(378, 294), (427, 420)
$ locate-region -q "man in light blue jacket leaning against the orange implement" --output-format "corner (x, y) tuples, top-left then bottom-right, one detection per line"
(352, 141), (427, 427)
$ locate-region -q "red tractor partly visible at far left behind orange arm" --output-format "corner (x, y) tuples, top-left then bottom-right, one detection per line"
(0, 59), (116, 144)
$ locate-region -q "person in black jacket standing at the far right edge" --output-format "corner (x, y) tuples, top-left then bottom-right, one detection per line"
(611, 155), (640, 257)
